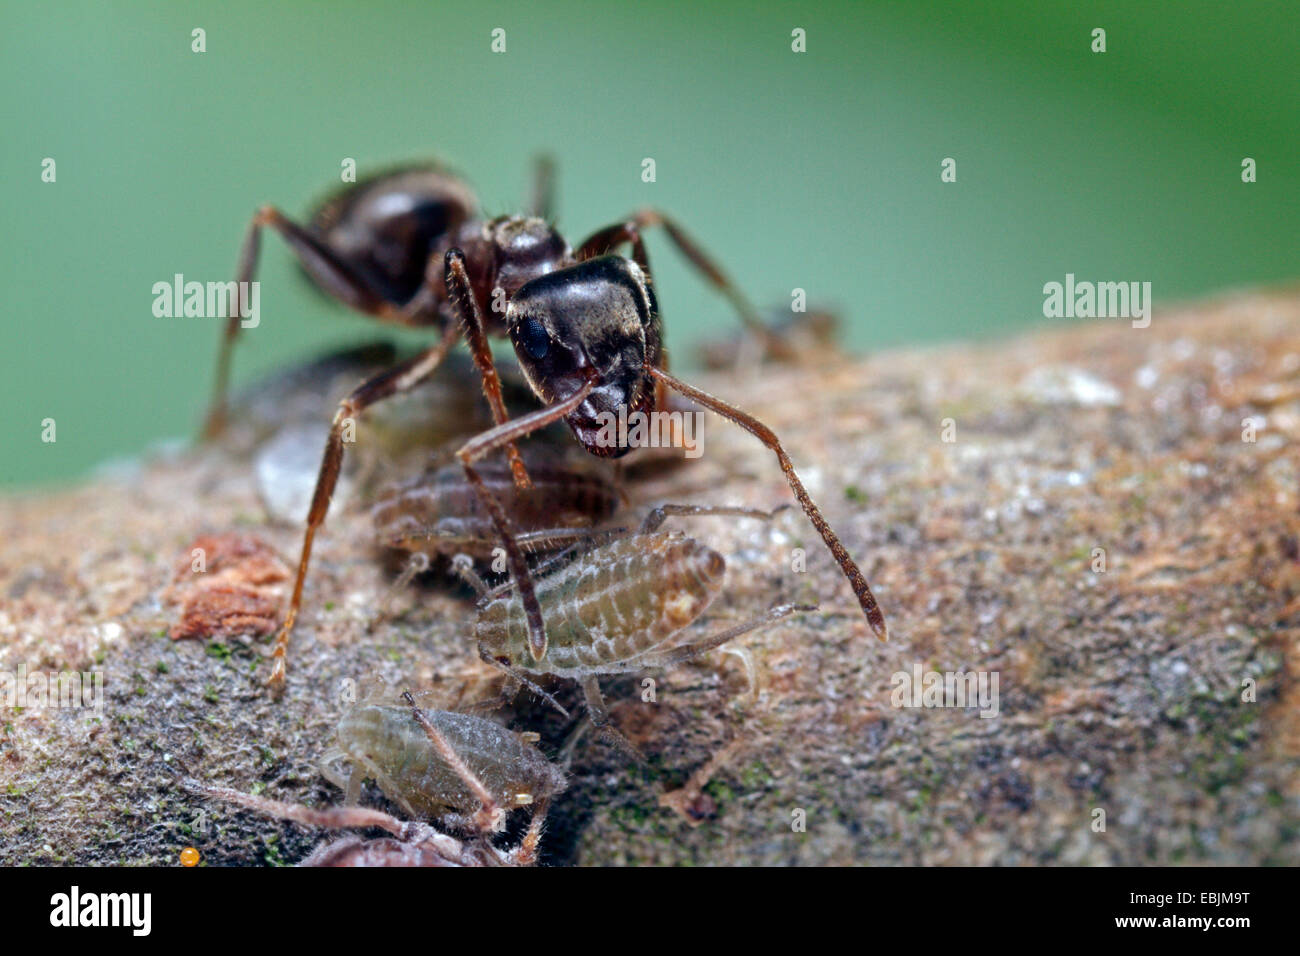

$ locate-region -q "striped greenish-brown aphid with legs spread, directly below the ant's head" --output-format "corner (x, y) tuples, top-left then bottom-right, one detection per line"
(456, 505), (816, 753)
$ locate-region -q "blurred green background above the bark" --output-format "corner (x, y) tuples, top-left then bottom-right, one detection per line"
(0, 0), (1300, 485)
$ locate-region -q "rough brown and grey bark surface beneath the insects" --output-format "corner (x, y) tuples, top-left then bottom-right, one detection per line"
(0, 291), (1300, 865)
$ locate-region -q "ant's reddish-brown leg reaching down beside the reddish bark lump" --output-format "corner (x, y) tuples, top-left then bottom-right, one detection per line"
(270, 324), (459, 687)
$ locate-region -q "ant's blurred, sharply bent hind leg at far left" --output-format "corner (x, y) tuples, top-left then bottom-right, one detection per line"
(203, 206), (399, 438)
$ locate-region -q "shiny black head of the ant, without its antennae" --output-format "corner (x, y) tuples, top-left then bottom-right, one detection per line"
(506, 255), (659, 458)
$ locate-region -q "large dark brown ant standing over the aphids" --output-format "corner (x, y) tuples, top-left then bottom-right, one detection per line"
(200, 163), (887, 685)
